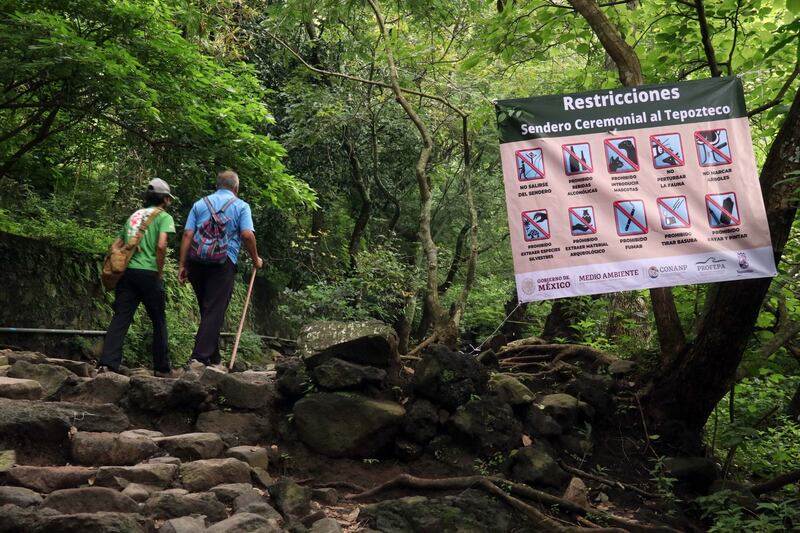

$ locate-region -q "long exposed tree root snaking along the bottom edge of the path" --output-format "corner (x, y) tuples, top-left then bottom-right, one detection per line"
(345, 474), (680, 533)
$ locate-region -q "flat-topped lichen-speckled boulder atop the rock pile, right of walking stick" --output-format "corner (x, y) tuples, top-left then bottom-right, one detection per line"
(297, 321), (398, 368)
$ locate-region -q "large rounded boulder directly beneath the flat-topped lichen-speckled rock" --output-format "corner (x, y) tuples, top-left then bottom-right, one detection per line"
(294, 392), (405, 458)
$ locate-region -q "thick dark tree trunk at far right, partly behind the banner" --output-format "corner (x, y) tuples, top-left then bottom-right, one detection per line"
(644, 87), (800, 435)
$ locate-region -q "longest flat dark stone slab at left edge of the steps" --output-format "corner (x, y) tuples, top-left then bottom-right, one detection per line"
(0, 398), (129, 442)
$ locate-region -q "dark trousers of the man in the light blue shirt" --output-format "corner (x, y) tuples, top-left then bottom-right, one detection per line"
(186, 259), (236, 365)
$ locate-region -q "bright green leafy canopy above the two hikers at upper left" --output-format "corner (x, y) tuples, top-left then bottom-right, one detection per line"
(0, 0), (313, 237)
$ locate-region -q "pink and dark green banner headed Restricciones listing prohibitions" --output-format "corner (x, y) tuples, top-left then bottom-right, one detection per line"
(496, 78), (776, 302)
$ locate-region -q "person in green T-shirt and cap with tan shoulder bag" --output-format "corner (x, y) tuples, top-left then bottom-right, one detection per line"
(99, 178), (176, 377)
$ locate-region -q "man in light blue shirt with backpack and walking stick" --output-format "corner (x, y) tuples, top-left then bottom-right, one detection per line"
(178, 170), (264, 365)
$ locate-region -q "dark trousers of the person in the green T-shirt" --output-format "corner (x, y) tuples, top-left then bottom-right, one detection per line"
(100, 268), (170, 372)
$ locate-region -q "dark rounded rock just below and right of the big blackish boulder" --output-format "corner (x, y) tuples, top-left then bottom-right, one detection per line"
(450, 398), (522, 454)
